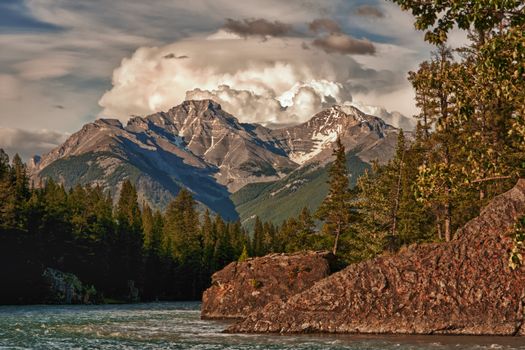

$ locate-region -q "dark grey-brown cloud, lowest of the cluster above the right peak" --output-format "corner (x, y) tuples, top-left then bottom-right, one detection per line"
(313, 33), (376, 55)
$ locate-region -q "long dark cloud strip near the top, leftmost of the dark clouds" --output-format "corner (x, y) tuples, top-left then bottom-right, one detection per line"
(223, 18), (292, 37)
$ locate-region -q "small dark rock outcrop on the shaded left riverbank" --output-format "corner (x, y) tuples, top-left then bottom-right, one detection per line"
(42, 267), (97, 304)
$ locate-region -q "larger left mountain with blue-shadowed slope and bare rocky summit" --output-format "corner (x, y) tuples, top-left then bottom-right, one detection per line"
(31, 100), (297, 219)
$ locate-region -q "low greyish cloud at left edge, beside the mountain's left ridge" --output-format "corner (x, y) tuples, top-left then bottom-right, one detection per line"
(0, 127), (68, 160)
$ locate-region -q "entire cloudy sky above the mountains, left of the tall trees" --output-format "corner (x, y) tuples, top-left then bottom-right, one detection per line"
(0, 0), (444, 159)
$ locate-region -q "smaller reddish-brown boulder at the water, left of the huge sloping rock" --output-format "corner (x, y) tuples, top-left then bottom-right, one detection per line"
(201, 252), (330, 319)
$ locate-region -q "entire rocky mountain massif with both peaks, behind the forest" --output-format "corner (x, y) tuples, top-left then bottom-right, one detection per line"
(30, 100), (397, 221)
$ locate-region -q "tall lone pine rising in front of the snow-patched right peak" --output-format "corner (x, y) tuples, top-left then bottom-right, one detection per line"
(317, 137), (352, 255)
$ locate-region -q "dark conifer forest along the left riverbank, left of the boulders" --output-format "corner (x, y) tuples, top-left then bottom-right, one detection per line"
(0, 154), (250, 303)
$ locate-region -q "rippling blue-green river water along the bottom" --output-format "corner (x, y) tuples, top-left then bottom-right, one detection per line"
(0, 303), (525, 350)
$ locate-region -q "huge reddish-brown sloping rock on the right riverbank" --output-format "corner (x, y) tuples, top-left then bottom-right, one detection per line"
(229, 180), (525, 335)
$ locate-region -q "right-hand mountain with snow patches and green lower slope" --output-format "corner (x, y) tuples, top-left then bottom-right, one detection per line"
(231, 106), (398, 227)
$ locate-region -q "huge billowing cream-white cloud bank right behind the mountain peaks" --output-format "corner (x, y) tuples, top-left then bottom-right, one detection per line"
(99, 36), (408, 125)
